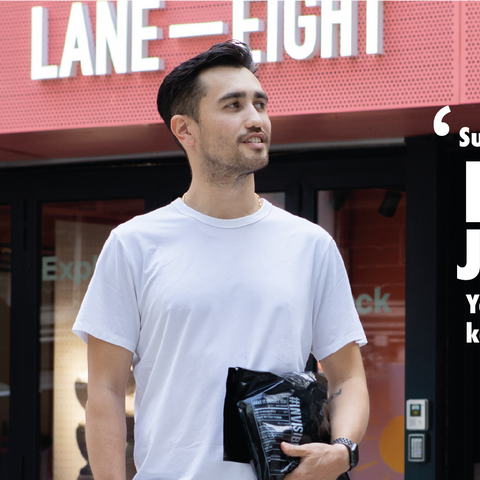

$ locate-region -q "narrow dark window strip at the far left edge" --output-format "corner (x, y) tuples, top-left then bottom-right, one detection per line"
(0, 205), (12, 479)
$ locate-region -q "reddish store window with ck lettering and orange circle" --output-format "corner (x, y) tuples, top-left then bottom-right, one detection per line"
(317, 188), (406, 480)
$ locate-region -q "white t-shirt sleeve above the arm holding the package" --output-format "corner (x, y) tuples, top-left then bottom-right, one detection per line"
(312, 239), (367, 360)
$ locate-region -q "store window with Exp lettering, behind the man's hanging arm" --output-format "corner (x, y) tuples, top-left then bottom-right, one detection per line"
(39, 200), (144, 480)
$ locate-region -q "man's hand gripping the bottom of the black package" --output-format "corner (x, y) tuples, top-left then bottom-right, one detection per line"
(280, 442), (350, 480)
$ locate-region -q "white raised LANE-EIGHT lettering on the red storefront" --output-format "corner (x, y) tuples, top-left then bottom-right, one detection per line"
(31, 0), (383, 80)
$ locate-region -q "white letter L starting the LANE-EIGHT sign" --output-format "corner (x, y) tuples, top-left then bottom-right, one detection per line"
(31, 7), (58, 80)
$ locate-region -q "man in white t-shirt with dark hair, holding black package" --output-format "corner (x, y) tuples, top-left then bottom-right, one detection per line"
(74, 42), (368, 480)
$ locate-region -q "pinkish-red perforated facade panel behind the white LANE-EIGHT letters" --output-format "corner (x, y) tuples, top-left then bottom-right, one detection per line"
(0, 0), (480, 133)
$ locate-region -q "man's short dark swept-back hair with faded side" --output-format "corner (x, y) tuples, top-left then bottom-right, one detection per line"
(157, 40), (257, 150)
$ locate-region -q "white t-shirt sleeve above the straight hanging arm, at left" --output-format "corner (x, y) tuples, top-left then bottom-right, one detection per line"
(72, 231), (140, 353)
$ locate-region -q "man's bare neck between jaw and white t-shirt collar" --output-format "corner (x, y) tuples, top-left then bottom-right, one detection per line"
(183, 174), (260, 219)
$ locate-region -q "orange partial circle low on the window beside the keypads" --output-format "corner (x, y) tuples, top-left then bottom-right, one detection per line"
(379, 415), (405, 473)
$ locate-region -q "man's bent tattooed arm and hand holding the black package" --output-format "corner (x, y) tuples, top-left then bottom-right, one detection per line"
(282, 343), (369, 480)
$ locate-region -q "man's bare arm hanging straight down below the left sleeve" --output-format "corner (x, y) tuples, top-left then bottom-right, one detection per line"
(85, 335), (133, 480)
